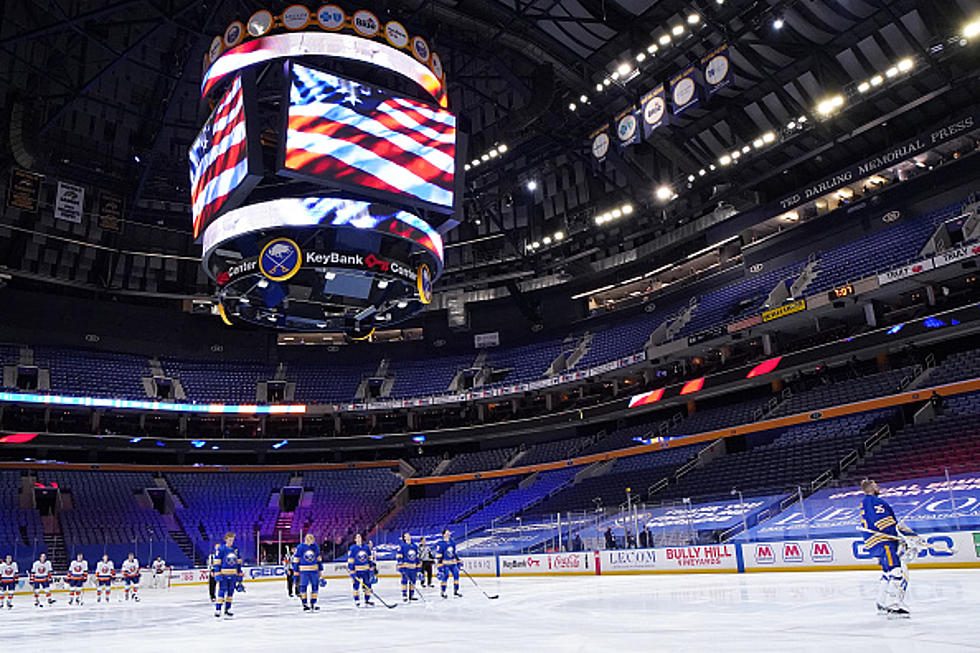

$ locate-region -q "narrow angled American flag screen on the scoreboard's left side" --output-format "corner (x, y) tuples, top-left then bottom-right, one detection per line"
(188, 77), (248, 238)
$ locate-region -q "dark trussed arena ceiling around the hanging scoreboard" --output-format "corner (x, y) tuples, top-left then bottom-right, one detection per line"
(0, 0), (978, 300)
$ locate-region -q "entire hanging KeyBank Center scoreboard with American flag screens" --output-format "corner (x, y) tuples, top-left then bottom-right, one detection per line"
(194, 4), (466, 334)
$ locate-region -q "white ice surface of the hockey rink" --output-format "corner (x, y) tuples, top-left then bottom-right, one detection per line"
(0, 570), (980, 653)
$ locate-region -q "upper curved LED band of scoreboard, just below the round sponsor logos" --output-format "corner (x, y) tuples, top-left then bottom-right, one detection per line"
(201, 32), (449, 108)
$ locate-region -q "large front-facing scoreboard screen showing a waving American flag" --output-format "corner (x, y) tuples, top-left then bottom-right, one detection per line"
(285, 65), (456, 207)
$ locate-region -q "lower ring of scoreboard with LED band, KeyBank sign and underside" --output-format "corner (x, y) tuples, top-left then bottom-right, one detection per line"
(203, 197), (442, 332)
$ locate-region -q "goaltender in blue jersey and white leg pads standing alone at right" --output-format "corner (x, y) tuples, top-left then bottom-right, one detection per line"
(861, 479), (914, 618)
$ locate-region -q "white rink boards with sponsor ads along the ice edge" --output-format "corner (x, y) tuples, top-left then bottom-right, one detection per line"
(9, 531), (980, 594)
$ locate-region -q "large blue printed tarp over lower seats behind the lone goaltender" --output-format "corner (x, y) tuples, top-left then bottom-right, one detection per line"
(737, 474), (980, 541)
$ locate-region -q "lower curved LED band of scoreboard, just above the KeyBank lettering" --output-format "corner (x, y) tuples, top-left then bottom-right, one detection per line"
(204, 197), (443, 278)
